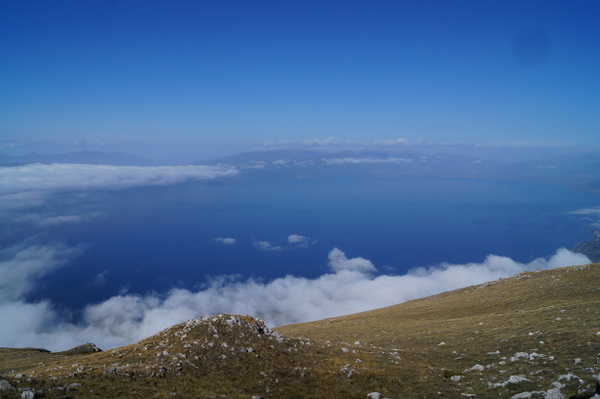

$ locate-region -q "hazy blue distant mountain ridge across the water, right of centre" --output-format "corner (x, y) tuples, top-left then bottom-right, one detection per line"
(197, 145), (600, 189)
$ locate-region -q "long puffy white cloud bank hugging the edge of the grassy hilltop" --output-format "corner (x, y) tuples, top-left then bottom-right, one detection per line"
(0, 247), (590, 350)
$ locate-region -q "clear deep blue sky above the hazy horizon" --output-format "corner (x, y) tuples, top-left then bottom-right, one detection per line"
(0, 0), (600, 159)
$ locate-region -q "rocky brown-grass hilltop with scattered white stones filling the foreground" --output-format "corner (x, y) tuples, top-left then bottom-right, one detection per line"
(0, 264), (600, 399)
